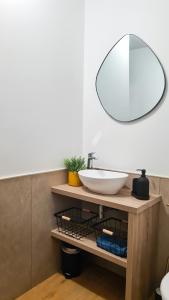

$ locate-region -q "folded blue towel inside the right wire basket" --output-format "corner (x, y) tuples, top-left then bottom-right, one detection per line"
(96, 235), (127, 257)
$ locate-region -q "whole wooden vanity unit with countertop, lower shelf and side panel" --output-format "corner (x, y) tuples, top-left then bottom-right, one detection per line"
(52, 184), (161, 300)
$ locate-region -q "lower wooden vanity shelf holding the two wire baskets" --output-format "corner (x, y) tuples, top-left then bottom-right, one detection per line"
(51, 229), (127, 268)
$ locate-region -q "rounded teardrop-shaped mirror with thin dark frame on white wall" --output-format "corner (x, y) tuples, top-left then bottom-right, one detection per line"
(96, 34), (165, 122)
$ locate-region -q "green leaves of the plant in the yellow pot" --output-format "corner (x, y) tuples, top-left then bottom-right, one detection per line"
(64, 156), (86, 172)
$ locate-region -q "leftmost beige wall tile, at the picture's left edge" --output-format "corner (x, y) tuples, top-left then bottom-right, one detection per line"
(0, 177), (31, 300)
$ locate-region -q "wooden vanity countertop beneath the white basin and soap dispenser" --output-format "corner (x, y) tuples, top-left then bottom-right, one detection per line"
(52, 184), (161, 214)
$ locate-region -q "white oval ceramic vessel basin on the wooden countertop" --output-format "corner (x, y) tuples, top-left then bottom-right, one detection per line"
(78, 169), (128, 195)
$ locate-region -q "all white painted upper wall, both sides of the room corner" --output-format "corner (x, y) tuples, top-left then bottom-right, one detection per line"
(0, 0), (169, 176)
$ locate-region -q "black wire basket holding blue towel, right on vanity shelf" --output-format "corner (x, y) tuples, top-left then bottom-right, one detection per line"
(93, 218), (128, 257)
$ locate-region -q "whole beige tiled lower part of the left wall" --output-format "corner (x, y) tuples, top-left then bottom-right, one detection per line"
(0, 170), (81, 300)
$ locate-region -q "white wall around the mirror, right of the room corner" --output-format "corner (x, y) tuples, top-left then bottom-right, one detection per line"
(83, 0), (169, 176)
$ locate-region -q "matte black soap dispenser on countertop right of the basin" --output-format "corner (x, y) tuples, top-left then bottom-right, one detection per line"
(131, 169), (149, 200)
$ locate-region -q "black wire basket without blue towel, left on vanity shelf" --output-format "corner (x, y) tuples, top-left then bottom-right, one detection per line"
(54, 207), (98, 240)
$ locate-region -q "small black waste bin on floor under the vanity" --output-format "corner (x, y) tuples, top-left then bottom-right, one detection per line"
(61, 243), (82, 279)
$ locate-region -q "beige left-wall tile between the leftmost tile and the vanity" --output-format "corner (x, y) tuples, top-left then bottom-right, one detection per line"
(32, 171), (78, 286)
